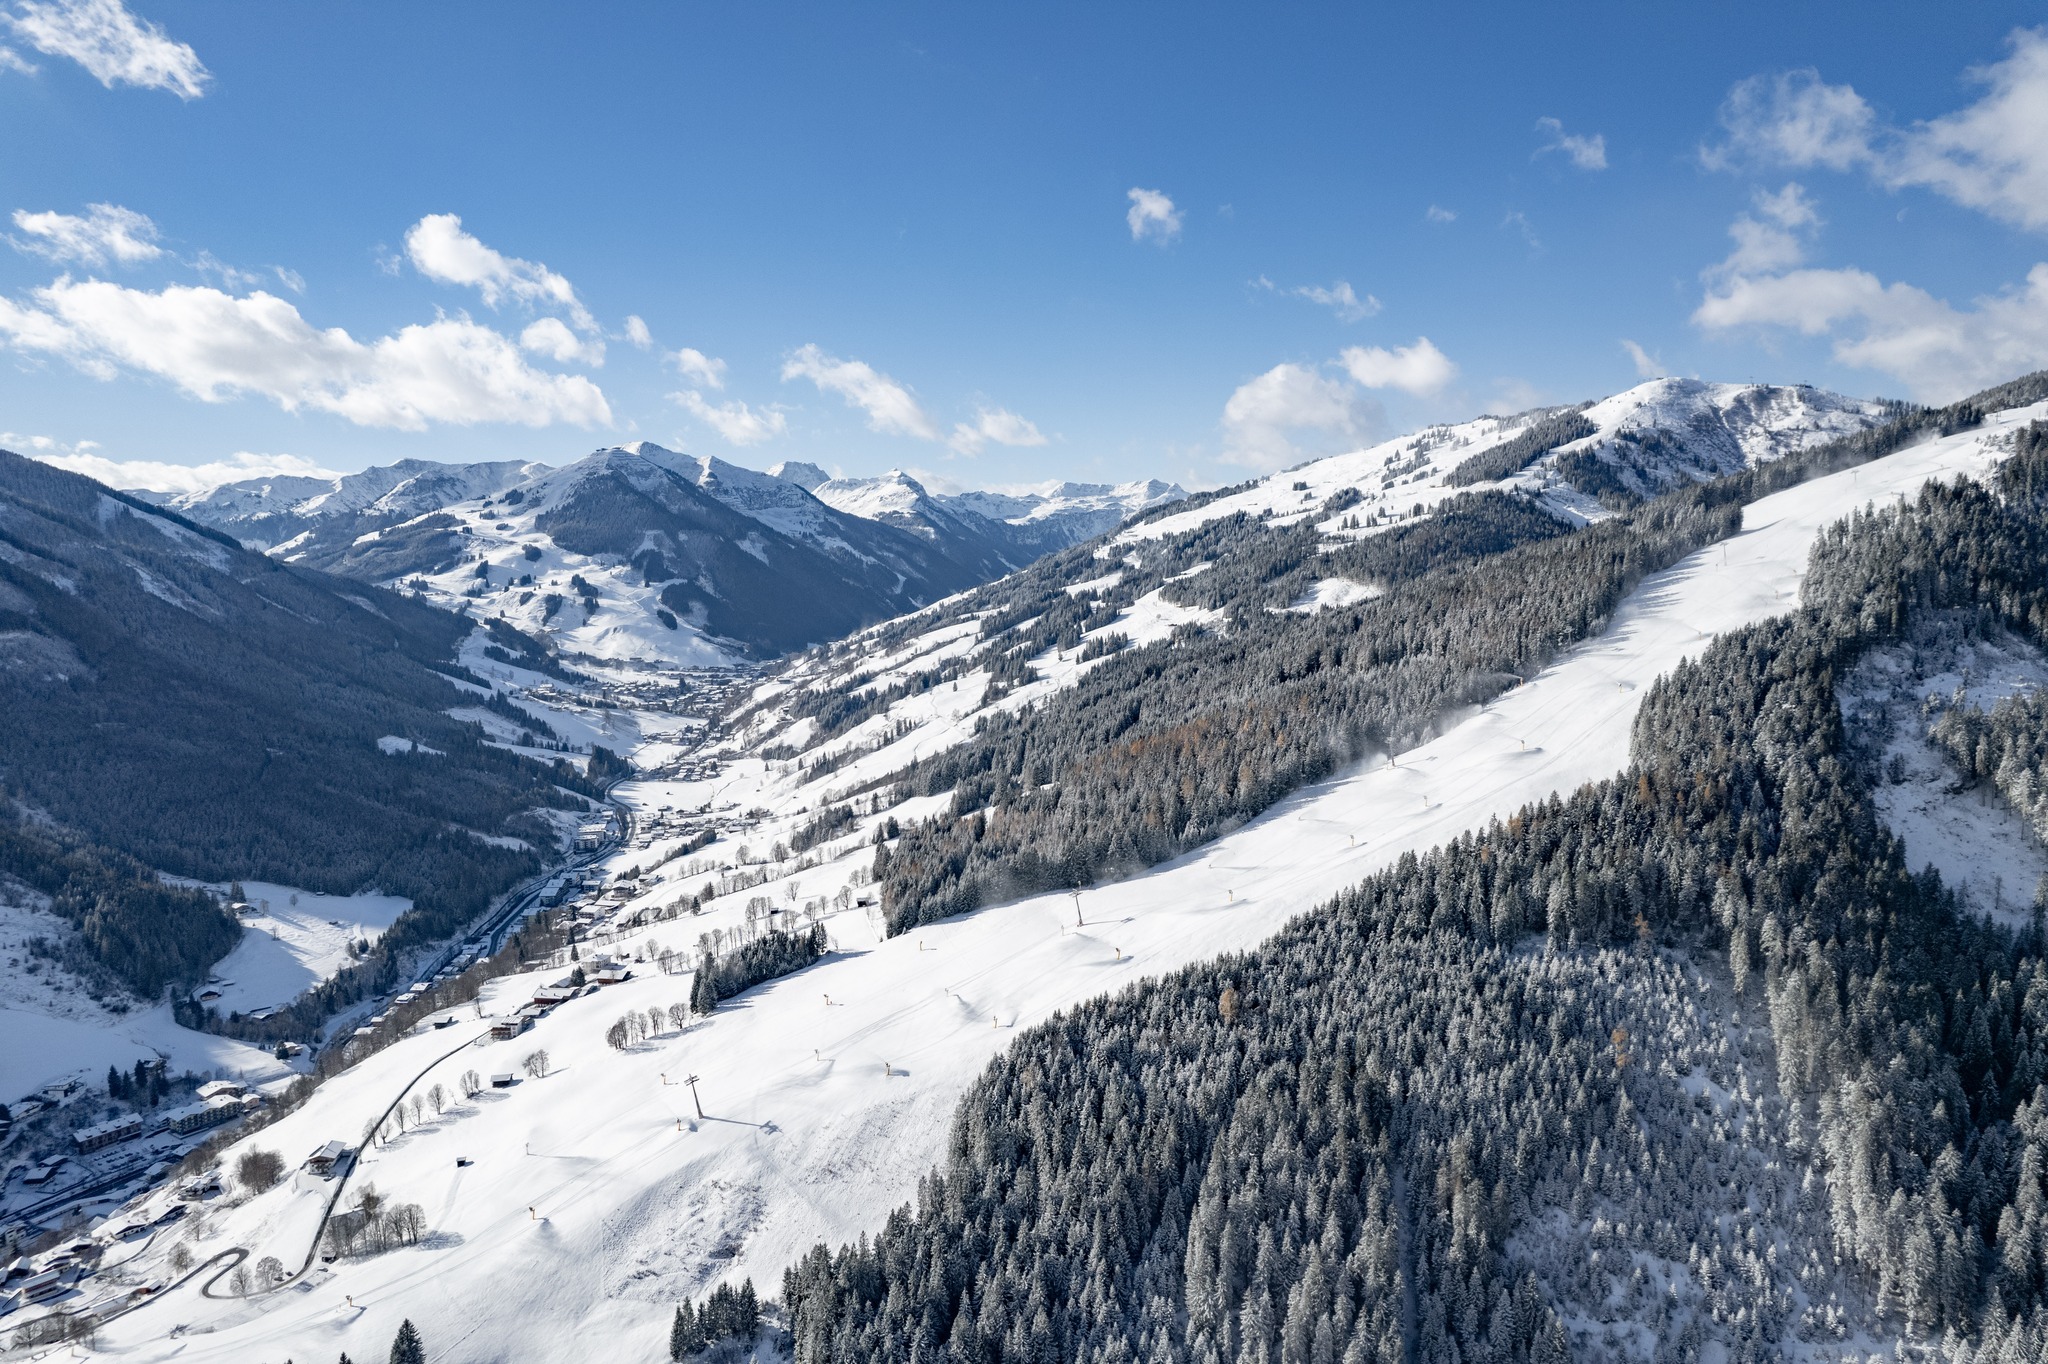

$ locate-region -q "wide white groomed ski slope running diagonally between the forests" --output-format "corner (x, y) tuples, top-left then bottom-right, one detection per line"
(72, 403), (2048, 1364)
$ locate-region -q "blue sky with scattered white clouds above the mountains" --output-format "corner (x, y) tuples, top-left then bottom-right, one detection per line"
(0, 0), (2048, 487)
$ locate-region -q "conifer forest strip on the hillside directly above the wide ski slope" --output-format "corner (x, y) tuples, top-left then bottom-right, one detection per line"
(851, 382), (2013, 930)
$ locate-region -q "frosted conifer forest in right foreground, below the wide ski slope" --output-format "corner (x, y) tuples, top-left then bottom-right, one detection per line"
(784, 401), (2048, 1364)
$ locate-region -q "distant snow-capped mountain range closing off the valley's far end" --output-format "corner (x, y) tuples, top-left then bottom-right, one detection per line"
(163, 440), (1186, 666)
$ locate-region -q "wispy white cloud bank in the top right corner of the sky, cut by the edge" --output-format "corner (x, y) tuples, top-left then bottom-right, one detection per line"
(1702, 29), (2048, 231)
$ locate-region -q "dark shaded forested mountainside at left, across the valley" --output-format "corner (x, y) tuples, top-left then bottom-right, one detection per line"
(0, 453), (588, 995)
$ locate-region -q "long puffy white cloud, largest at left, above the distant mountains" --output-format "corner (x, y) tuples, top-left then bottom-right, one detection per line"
(0, 276), (610, 430)
